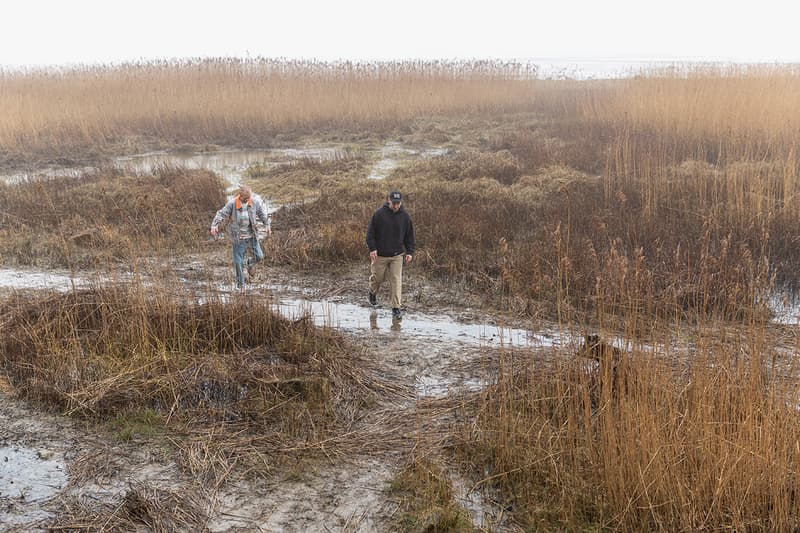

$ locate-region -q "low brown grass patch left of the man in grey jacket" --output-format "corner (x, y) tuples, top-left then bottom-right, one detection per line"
(0, 168), (225, 267)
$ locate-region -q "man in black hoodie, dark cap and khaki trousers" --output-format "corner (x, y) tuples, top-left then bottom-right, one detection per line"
(367, 191), (415, 318)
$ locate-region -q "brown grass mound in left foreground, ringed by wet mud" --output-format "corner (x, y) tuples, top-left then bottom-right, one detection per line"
(0, 285), (381, 482)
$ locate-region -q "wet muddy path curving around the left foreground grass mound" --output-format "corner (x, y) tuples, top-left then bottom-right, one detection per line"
(0, 245), (573, 531)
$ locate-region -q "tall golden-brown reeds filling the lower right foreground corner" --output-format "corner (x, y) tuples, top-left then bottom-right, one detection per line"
(456, 322), (800, 531)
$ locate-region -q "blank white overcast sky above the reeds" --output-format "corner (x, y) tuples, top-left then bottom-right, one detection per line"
(0, 0), (800, 67)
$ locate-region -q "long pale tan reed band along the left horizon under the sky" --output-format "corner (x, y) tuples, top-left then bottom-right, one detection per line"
(0, 59), (535, 162)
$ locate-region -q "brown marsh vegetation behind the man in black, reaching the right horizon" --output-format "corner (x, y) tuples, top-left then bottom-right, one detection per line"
(262, 64), (800, 320)
